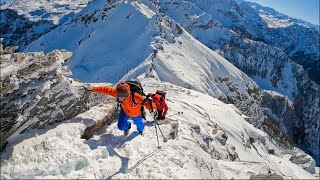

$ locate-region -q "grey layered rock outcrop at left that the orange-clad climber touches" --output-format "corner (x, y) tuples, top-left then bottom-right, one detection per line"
(0, 41), (103, 149)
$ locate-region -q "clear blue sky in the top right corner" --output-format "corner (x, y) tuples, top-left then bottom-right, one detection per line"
(246, 0), (320, 25)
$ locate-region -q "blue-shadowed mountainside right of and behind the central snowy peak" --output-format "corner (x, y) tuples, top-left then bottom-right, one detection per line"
(141, 0), (320, 165)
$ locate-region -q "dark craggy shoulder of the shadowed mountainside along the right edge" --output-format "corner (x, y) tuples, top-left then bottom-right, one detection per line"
(220, 38), (320, 165)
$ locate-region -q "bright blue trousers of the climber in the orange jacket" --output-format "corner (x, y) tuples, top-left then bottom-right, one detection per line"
(118, 109), (144, 132)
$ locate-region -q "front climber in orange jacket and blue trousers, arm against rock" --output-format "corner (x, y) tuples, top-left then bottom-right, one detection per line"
(91, 82), (156, 135)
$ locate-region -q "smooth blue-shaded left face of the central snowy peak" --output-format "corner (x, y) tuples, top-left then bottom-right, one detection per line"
(26, 0), (157, 82)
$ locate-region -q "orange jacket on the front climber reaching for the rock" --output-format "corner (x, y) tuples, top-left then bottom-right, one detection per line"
(92, 83), (156, 117)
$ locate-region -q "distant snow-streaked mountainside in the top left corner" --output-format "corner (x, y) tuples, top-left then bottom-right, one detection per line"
(0, 0), (90, 51)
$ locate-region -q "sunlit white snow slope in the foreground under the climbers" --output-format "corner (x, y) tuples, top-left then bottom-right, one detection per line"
(1, 79), (316, 179)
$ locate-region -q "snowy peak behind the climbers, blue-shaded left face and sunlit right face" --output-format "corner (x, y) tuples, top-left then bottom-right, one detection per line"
(27, 1), (262, 124)
